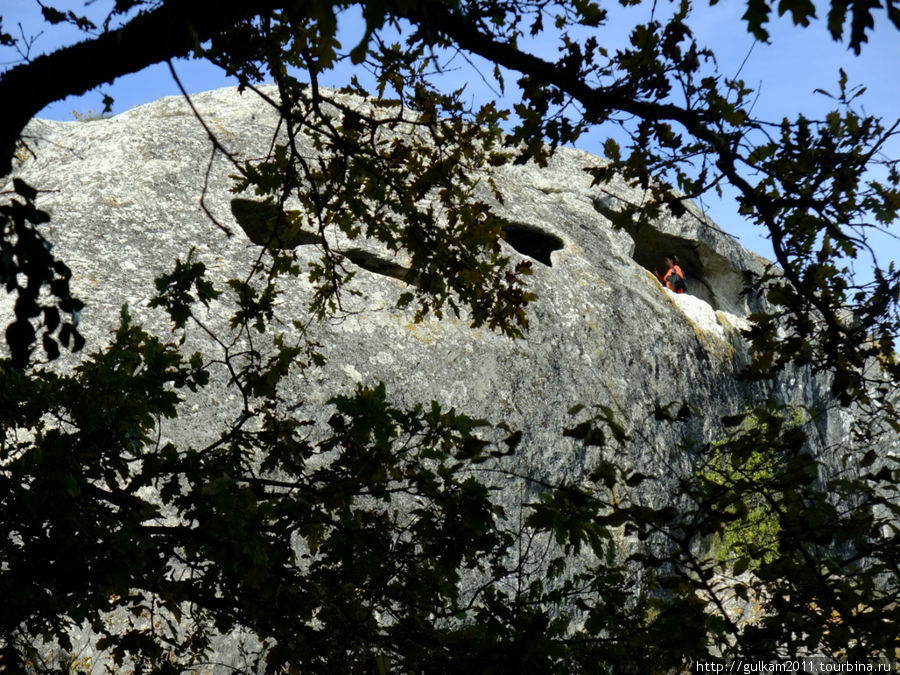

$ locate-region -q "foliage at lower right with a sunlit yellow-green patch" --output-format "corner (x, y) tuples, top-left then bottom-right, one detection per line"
(666, 406), (900, 659)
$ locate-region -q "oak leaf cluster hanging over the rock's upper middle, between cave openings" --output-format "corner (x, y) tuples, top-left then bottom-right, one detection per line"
(229, 77), (533, 336)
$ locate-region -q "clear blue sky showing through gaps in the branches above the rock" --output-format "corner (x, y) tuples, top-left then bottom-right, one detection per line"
(0, 0), (900, 266)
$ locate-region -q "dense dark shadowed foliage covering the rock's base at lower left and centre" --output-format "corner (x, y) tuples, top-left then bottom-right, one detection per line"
(0, 300), (652, 673)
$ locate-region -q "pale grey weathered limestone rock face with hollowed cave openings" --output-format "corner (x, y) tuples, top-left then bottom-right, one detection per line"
(0, 89), (845, 672)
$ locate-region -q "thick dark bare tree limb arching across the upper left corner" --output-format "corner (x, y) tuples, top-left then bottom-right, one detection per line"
(0, 0), (284, 176)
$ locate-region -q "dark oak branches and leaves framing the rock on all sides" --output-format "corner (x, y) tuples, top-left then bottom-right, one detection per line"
(0, 0), (900, 673)
